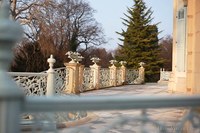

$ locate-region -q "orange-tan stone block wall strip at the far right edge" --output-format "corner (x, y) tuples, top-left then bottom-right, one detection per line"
(187, 0), (200, 93)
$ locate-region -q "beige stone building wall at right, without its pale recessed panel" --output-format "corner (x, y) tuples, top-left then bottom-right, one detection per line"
(169, 0), (200, 94)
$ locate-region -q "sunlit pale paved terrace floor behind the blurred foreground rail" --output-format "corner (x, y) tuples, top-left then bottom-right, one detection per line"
(60, 83), (188, 133)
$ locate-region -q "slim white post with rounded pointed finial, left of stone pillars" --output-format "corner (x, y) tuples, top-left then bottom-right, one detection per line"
(46, 55), (56, 96)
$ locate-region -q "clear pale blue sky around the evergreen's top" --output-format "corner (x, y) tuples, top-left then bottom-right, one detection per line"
(87, 0), (173, 50)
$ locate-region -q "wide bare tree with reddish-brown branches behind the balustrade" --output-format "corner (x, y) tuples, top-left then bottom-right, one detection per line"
(10, 0), (105, 71)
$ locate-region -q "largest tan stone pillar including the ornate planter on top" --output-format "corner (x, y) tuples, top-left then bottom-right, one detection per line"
(64, 51), (83, 94)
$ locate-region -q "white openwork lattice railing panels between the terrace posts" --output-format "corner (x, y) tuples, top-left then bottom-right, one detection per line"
(9, 67), (139, 96)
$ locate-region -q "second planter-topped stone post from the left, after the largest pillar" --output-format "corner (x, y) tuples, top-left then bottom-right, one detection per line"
(90, 57), (101, 89)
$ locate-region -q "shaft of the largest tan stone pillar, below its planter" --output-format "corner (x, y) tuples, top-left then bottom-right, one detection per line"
(64, 63), (80, 94)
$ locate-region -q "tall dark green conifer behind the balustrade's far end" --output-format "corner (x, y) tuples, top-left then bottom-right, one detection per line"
(116, 0), (163, 81)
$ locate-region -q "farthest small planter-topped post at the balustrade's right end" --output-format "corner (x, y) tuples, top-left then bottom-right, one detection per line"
(133, 62), (145, 84)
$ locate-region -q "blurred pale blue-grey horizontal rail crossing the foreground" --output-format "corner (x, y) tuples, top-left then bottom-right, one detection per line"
(23, 95), (200, 112)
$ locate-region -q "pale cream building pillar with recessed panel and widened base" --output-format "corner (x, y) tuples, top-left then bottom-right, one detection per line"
(168, 0), (190, 92)
